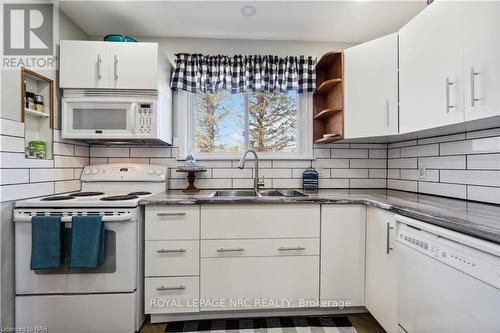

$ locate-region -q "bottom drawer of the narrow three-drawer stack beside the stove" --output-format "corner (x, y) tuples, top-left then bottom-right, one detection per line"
(144, 277), (200, 314)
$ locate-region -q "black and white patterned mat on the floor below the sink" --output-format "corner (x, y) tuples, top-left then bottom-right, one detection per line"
(165, 316), (357, 333)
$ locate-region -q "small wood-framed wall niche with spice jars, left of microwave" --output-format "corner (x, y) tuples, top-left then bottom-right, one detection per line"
(20, 68), (54, 159)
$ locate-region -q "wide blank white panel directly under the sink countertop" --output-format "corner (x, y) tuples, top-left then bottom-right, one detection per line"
(201, 204), (320, 239)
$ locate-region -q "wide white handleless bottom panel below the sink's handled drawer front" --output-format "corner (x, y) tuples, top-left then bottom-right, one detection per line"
(200, 256), (319, 311)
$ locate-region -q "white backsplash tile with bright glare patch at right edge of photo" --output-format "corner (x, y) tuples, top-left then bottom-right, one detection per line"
(440, 136), (500, 155)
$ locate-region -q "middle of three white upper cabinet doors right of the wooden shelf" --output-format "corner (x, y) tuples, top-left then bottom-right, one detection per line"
(399, 1), (464, 133)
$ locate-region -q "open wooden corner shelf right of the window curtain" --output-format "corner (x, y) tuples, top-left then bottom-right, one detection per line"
(313, 51), (344, 144)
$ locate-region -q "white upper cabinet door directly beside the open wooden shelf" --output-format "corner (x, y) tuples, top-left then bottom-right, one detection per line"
(344, 33), (398, 138)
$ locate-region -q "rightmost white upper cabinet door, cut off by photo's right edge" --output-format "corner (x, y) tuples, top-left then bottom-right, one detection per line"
(460, 1), (500, 120)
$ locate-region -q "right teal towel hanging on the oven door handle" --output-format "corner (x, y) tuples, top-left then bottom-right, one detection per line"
(69, 216), (104, 268)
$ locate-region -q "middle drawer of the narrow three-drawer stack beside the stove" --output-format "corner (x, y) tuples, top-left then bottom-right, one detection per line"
(144, 241), (200, 276)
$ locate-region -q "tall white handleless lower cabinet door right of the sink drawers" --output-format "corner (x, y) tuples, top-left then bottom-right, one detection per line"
(320, 205), (366, 306)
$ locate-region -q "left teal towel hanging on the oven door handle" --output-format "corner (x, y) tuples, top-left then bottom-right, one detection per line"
(30, 216), (63, 270)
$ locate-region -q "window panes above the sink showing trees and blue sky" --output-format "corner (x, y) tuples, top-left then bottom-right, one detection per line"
(194, 92), (298, 152)
